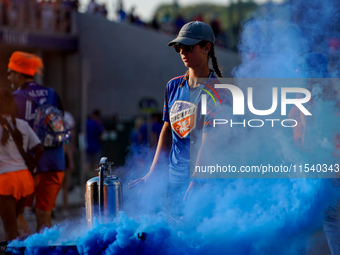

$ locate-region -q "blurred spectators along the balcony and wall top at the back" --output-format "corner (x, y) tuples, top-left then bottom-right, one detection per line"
(0, 0), (227, 47)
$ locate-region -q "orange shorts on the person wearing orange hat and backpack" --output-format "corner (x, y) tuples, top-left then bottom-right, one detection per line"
(26, 172), (64, 212)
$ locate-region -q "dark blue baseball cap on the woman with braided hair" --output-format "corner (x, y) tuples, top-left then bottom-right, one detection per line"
(168, 21), (215, 46)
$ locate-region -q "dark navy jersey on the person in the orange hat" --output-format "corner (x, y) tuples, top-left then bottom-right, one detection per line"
(13, 82), (65, 172)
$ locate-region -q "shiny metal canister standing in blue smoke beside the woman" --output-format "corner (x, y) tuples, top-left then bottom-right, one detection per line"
(85, 157), (123, 227)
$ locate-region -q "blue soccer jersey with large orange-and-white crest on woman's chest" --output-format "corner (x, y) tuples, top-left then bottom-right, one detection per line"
(163, 71), (228, 183)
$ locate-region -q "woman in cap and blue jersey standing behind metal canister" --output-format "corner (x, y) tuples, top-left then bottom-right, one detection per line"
(129, 21), (222, 215)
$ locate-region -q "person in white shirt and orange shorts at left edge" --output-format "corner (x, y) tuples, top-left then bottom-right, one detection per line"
(0, 87), (44, 241)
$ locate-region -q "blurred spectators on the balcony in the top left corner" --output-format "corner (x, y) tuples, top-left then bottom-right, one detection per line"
(0, 0), (78, 32)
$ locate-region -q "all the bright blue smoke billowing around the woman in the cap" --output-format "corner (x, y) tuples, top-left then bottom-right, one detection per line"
(7, 0), (340, 255)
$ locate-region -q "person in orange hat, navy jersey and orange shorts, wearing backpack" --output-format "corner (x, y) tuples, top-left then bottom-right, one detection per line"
(8, 51), (65, 231)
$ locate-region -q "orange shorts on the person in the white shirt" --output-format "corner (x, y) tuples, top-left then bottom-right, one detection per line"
(0, 169), (34, 201)
